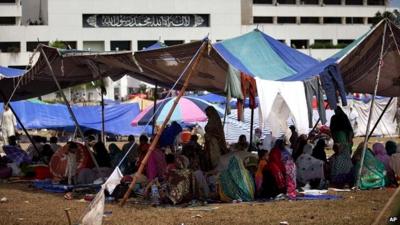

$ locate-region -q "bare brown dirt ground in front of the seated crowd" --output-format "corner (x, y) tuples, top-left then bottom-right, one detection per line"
(0, 183), (399, 225)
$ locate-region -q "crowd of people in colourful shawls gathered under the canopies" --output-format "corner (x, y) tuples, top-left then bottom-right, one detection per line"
(0, 107), (400, 204)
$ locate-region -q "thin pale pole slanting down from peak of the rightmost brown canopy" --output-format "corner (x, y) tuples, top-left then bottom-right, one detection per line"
(356, 23), (387, 188)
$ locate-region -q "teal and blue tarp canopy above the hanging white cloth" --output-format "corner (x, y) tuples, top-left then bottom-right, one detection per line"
(213, 30), (318, 80)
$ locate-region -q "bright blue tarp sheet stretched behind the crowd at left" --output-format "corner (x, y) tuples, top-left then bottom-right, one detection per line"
(0, 101), (151, 135)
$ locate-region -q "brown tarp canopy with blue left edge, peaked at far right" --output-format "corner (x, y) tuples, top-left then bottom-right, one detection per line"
(282, 20), (400, 97)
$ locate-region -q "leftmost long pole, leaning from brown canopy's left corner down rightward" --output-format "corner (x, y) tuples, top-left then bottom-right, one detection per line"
(40, 48), (101, 174)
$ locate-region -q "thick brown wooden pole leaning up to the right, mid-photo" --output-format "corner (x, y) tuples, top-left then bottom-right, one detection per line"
(120, 41), (208, 207)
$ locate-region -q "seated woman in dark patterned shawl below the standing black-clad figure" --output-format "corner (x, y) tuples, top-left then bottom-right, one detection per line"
(329, 143), (354, 187)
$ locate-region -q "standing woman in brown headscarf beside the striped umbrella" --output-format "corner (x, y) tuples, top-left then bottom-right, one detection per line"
(201, 106), (229, 171)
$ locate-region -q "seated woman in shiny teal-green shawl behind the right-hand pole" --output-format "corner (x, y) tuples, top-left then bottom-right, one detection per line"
(353, 142), (388, 189)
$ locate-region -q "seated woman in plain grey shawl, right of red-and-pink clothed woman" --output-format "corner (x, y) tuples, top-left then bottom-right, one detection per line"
(296, 144), (325, 186)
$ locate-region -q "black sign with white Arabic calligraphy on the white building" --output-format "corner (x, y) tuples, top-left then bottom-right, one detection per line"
(82, 14), (210, 27)
